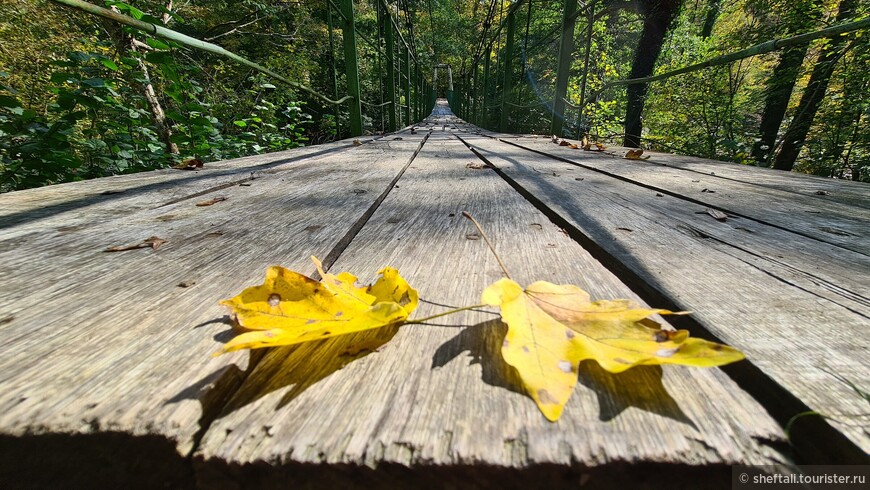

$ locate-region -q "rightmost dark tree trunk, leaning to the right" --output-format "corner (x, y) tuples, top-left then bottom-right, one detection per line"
(773, 0), (858, 170)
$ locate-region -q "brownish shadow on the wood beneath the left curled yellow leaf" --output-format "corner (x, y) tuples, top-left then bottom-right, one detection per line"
(167, 326), (399, 427)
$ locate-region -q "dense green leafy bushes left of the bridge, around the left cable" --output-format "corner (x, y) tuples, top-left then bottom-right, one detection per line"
(0, 1), (320, 192)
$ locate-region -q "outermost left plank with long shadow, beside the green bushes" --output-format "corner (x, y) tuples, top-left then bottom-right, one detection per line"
(0, 138), (384, 239)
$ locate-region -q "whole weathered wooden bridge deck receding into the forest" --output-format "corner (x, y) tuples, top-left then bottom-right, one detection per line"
(0, 100), (870, 488)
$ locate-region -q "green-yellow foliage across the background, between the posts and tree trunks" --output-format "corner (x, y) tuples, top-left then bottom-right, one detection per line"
(0, 0), (870, 192)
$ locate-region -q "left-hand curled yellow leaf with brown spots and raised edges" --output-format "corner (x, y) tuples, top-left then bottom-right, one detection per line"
(218, 257), (418, 354)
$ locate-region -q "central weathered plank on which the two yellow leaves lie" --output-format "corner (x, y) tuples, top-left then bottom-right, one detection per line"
(196, 130), (784, 488)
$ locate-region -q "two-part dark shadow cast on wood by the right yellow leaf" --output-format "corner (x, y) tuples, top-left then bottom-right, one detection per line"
(432, 320), (697, 429)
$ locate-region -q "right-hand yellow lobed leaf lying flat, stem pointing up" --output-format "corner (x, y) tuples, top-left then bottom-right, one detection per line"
(482, 279), (743, 422)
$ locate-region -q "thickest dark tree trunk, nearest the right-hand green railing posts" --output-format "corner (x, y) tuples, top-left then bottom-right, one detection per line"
(622, 0), (681, 148)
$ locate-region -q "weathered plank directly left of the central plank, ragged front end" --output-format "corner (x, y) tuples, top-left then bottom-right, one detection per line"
(0, 138), (420, 486)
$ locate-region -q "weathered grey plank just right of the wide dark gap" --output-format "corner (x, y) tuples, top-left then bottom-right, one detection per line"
(467, 132), (870, 457)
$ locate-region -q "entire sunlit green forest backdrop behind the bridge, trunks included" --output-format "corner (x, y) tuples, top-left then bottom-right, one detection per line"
(0, 0), (870, 192)
